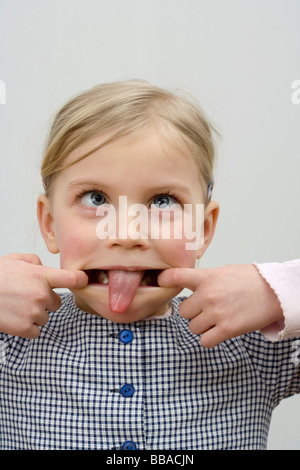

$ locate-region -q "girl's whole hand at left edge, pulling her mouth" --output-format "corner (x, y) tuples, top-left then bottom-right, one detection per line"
(0, 254), (88, 339)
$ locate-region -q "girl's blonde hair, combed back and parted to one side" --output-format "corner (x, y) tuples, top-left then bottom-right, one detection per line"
(41, 80), (215, 194)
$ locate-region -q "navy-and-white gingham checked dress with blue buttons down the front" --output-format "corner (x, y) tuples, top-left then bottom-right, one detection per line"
(0, 294), (299, 450)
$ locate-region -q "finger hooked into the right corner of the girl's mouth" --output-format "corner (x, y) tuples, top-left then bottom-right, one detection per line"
(157, 268), (202, 291)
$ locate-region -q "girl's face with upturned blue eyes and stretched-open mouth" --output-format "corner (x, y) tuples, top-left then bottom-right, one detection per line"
(38, 128), (218, 323)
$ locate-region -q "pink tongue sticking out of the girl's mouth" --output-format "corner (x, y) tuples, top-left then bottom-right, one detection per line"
(108, 269), (145, 313)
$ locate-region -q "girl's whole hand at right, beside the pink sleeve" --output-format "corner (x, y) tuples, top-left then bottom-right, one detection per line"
(158, 264), (283, 348)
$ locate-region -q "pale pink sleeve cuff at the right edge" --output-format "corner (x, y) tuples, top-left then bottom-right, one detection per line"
(253, 259), (300, 341)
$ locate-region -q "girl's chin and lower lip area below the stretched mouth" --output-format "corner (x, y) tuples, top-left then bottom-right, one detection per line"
(72, 286), (181, 323)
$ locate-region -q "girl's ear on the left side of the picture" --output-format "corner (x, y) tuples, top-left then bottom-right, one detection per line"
(37, 194), (59, 253)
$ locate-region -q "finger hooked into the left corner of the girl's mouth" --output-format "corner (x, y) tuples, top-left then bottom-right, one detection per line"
(44, 267), (88, 289)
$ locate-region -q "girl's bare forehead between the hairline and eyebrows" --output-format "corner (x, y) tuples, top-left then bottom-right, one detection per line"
(55, 128), (206, 197)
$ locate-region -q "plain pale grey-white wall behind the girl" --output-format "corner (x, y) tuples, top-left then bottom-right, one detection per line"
(0, 0), (300, 449)
